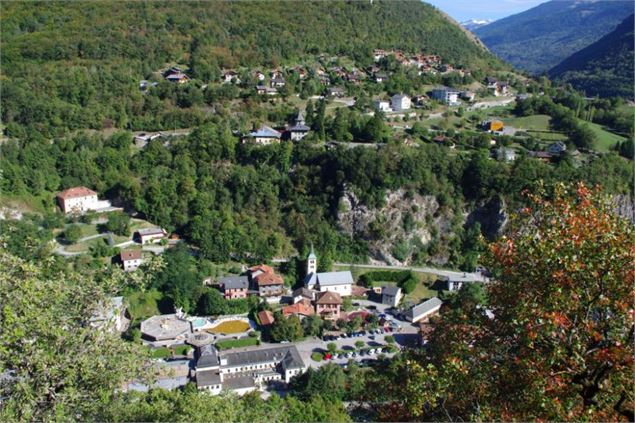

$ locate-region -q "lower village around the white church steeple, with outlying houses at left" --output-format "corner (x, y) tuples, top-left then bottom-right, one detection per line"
(57, 181), (488, 394)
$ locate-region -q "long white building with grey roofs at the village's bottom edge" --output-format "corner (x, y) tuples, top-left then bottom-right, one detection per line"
(196, 345), (306, 395)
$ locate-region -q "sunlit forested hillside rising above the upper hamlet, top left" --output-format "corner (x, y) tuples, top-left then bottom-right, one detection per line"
(0, 0), (497, 137)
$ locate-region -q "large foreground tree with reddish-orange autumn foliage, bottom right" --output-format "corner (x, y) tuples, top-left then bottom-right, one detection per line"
(369, 184), (635, 421)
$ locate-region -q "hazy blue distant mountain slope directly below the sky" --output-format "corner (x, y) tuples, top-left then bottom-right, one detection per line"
(474, 0), (633, 74)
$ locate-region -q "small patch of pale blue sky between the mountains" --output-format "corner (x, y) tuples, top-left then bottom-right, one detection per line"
(424, 0), (547, 22)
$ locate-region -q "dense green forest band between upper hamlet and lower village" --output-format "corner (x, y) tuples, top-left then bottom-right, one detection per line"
(0, 116), (633, 272)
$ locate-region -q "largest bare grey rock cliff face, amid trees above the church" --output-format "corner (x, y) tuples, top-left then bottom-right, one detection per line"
(337, 189), (452, 265)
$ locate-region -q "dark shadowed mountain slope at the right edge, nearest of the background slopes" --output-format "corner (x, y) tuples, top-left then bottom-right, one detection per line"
(549, 15), (634, 98)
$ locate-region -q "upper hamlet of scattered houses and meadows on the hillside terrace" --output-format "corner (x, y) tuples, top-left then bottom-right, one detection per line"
(134, 49), (615, 162)
